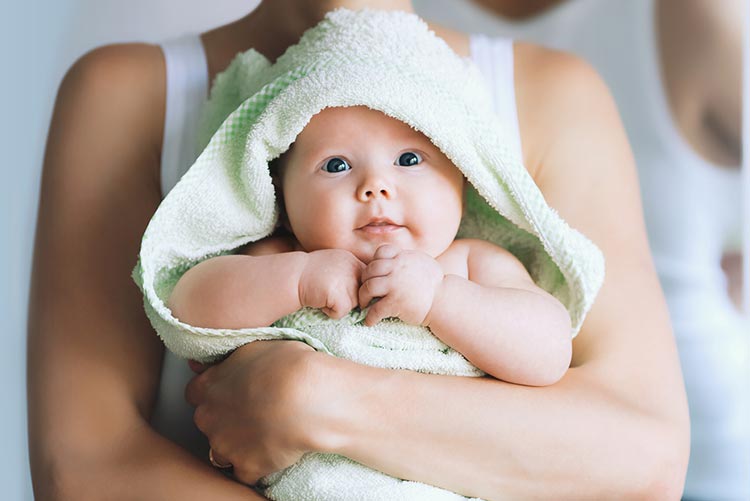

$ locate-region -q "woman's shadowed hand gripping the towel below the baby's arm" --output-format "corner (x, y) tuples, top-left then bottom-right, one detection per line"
(185, 341), (325, 485)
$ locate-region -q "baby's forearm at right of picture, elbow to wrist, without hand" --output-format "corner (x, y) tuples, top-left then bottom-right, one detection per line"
(428, 275), (572, 386)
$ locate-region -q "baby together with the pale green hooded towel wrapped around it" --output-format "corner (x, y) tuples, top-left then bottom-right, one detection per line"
(133, 9), (604, 501)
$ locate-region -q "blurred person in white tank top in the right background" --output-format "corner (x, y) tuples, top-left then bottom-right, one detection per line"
(462, 0), (750, 500)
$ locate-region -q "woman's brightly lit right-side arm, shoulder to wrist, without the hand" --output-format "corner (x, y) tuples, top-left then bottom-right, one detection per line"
(318, 44), (689, 499)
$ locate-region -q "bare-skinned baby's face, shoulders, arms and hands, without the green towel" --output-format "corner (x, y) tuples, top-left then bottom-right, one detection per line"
(168, 106), (571, 386)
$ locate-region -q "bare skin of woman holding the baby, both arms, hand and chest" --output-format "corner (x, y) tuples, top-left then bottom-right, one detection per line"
(29, 0), (688, 499)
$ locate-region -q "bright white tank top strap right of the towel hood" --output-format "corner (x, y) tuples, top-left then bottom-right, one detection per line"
(469, 34), (523, 158)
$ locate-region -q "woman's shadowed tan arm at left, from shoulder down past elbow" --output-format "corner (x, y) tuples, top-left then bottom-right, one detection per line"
(28, 45), (259, 499)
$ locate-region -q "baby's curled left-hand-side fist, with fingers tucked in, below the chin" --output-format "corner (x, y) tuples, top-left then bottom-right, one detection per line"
(299, 249), (365, 319)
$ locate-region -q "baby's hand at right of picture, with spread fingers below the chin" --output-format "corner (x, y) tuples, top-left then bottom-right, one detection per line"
(359, 244), (444, 325)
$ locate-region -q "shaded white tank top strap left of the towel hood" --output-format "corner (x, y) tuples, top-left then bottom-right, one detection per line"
(160, 34), (208, 197)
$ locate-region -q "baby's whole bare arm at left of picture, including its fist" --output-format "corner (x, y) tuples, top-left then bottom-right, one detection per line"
(167, 237), (364, 329)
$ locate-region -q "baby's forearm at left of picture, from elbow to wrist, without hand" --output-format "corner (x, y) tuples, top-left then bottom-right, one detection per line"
(167, 252), (307, 329)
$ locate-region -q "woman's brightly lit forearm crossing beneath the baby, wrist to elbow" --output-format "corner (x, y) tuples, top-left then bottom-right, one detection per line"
(314, 359), (684, 499)
